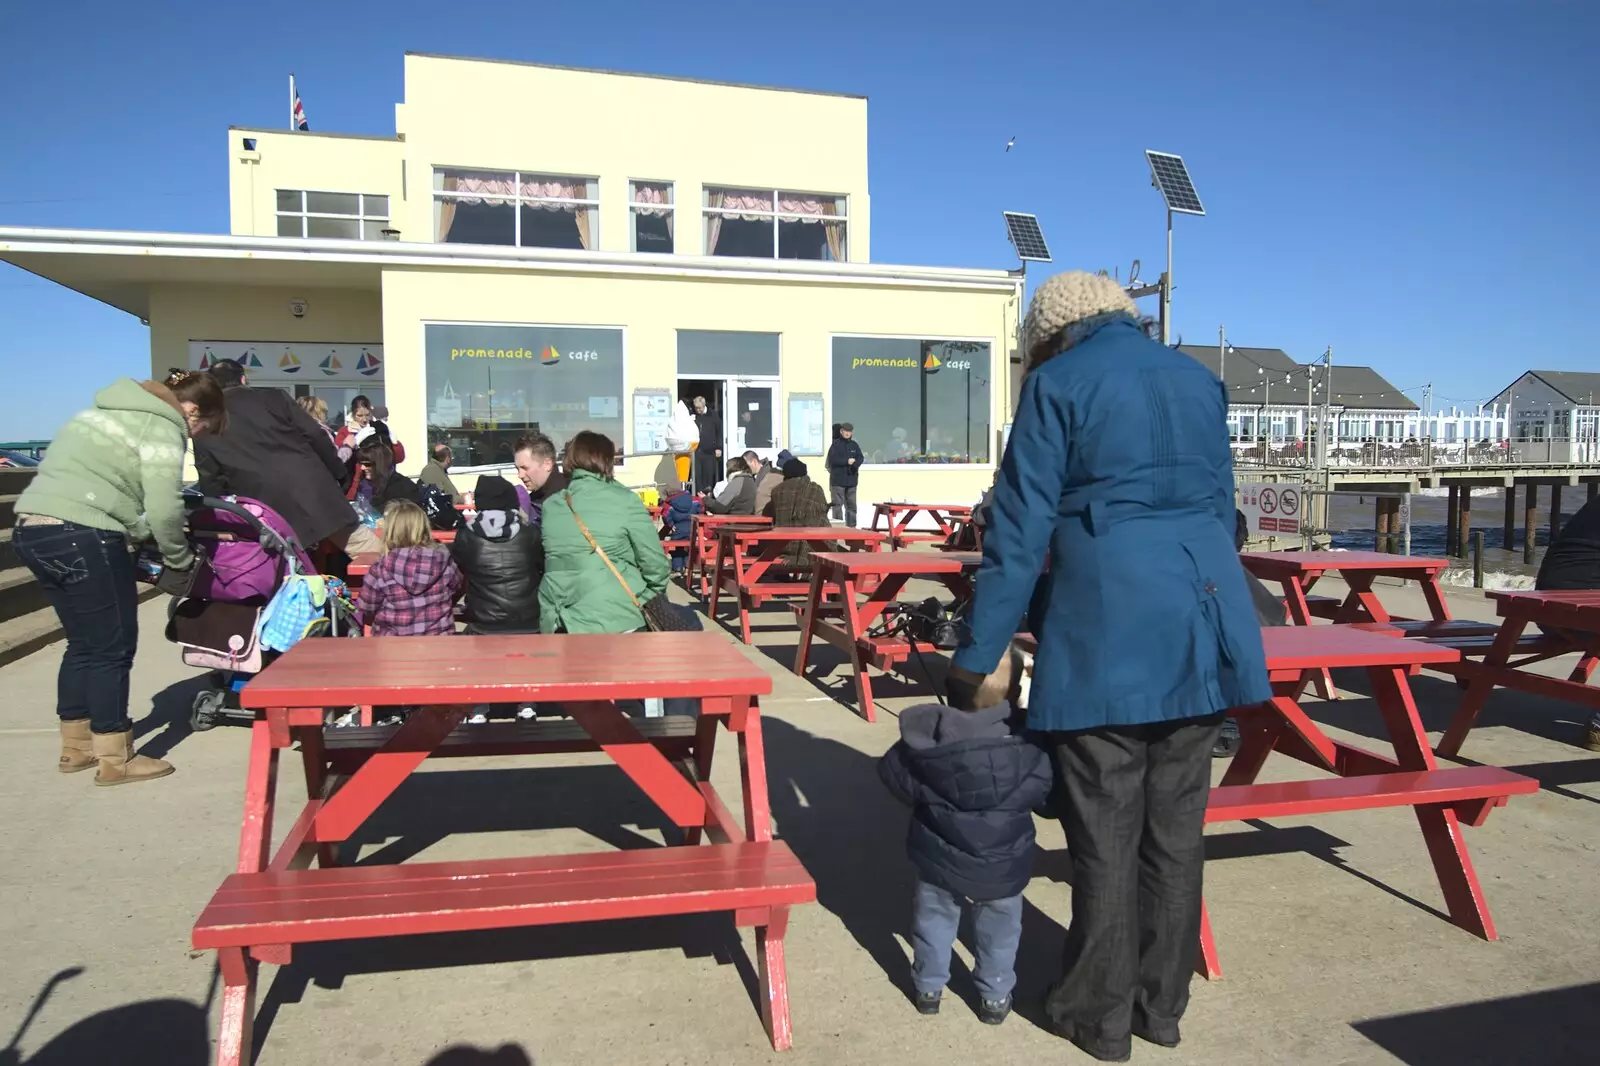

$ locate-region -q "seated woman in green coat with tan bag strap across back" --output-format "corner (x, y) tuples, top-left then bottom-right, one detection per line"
(539, 431), (672, 632)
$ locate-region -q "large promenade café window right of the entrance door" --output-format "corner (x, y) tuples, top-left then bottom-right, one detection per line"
(832, 336), (990, 463)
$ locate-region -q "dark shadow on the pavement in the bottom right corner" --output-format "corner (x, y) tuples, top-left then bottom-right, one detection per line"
(1350, 983), (1600, 1066)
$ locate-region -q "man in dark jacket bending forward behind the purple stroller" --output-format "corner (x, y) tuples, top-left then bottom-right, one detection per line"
(194, 359), (381, 554)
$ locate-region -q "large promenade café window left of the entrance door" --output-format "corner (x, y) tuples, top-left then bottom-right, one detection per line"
(424, 323), (624, 466)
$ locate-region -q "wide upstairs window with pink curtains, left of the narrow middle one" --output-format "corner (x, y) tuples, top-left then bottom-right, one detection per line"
(434, 166), (600, 248)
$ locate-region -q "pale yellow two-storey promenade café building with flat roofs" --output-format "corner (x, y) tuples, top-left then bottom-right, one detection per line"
(0, 54), (1021, 514)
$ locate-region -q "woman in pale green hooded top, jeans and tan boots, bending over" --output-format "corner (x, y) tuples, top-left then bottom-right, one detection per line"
(11, 371), (222, 784)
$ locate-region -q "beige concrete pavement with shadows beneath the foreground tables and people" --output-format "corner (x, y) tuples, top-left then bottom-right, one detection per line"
(0, 573), (1600, 1066)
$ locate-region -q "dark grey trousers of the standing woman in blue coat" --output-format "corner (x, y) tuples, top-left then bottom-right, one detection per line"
(1046, 715), (1222, 1058)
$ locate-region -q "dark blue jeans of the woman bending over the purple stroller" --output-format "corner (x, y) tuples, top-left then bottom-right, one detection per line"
(11, 522), (139, 733)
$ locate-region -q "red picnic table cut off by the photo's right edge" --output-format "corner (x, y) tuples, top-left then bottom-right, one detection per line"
(1427, 591), (1600, 759)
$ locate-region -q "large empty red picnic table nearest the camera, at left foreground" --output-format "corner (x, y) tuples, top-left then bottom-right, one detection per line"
(194, 632), (816, 1066)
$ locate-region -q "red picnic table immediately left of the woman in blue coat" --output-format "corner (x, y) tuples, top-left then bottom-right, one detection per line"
(795, 552), (982, 722)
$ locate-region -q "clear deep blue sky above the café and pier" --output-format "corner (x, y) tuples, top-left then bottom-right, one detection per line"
(0, 0), (1600, 437)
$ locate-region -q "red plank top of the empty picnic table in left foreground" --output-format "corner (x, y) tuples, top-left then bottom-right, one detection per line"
(240, 632), (773, 707)
